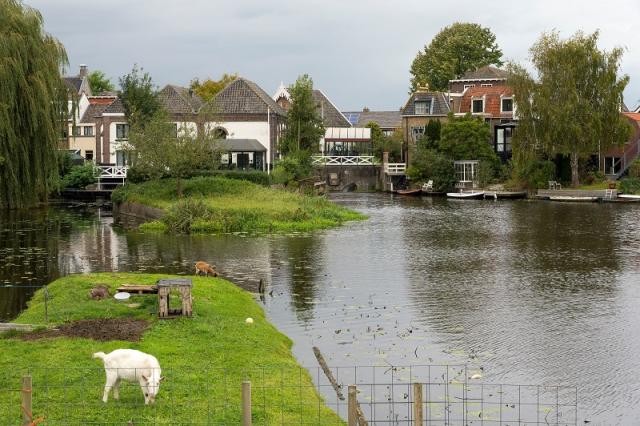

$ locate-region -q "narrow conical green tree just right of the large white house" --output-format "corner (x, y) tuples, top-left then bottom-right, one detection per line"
(280, 74), (324, 154)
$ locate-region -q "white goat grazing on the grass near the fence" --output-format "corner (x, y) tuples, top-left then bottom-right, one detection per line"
(93, 349), (164, 404)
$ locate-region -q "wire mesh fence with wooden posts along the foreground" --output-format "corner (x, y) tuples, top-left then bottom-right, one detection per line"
(0, 365), (577, 426)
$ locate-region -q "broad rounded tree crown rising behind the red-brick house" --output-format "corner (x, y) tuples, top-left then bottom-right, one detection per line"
(411, 22), (502, 92)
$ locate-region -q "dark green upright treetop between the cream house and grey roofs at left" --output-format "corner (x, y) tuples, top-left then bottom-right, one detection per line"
(118, 65), (160, 127)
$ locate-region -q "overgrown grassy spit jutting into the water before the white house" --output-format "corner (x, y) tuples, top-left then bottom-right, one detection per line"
(112, 177), (365, 233)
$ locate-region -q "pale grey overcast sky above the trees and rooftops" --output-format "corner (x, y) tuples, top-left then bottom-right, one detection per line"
(25, 0), (640, 111)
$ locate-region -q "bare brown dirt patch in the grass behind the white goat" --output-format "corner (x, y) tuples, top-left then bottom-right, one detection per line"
(20, 318), (149, 342)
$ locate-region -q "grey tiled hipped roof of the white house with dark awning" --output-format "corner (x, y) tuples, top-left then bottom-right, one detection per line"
(214, 78), (287, 116)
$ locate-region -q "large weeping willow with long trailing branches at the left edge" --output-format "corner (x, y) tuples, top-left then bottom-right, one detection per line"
(0, 0), (69, 208)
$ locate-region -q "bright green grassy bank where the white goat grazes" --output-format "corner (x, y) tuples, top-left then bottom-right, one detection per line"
(0, 273), (343, 425)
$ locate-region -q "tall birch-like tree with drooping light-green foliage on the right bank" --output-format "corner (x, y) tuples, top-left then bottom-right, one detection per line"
(508, 31), (630, 186)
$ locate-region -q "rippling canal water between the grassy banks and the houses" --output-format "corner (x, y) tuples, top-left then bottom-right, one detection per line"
(0, 194), (640, 424)
